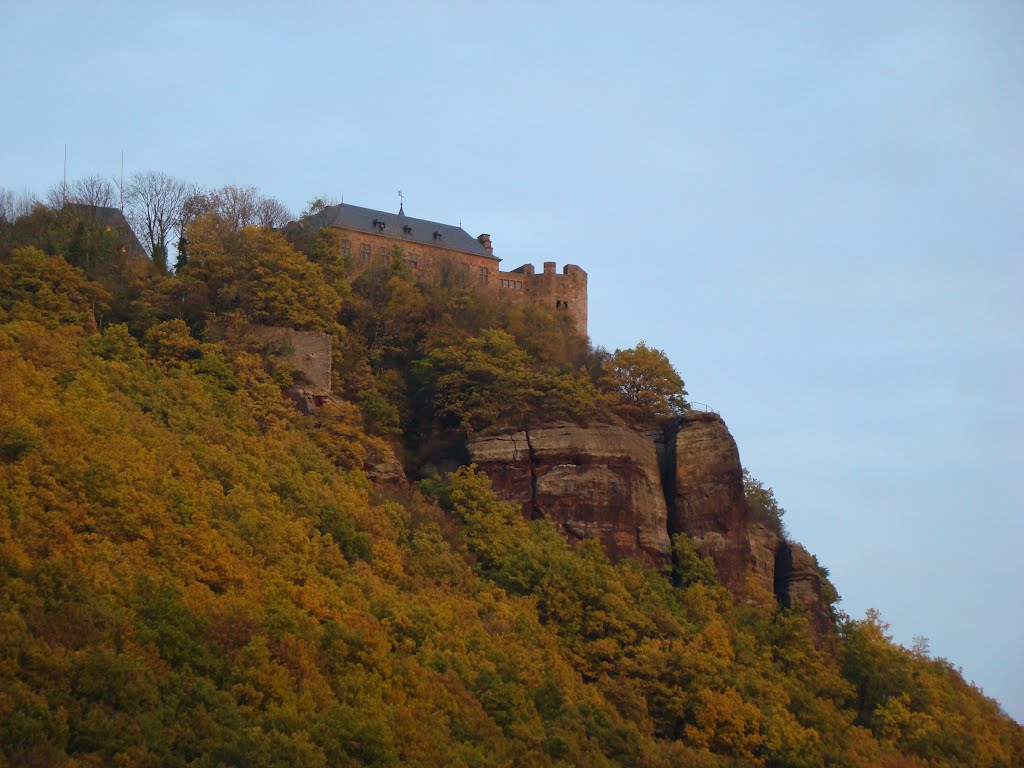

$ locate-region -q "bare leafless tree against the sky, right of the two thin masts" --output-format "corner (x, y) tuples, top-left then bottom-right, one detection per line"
(125, 171), (190, 273)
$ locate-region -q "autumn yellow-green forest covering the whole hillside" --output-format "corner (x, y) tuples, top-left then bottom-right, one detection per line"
(0, 188), (1024, 768)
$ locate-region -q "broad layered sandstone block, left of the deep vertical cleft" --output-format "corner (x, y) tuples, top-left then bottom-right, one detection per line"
(468, 423), (672, 565)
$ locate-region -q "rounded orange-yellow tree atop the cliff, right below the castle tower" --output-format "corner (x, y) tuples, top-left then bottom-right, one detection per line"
(598, 341), (688, 427)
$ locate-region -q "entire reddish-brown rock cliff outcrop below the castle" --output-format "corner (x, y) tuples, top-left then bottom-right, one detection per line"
(467, 412), (831, 636)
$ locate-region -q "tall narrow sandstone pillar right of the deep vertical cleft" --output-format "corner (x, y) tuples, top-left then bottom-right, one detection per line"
(659, 411), (751, 595)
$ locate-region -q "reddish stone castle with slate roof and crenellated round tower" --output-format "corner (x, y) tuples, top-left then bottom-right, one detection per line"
(289, 203), (587, 334)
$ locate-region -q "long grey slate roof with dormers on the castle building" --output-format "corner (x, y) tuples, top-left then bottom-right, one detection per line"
(304, 203), (501, 261)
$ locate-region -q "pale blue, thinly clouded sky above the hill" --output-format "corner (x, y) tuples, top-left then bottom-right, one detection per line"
(0, 0), (1024, 722)
